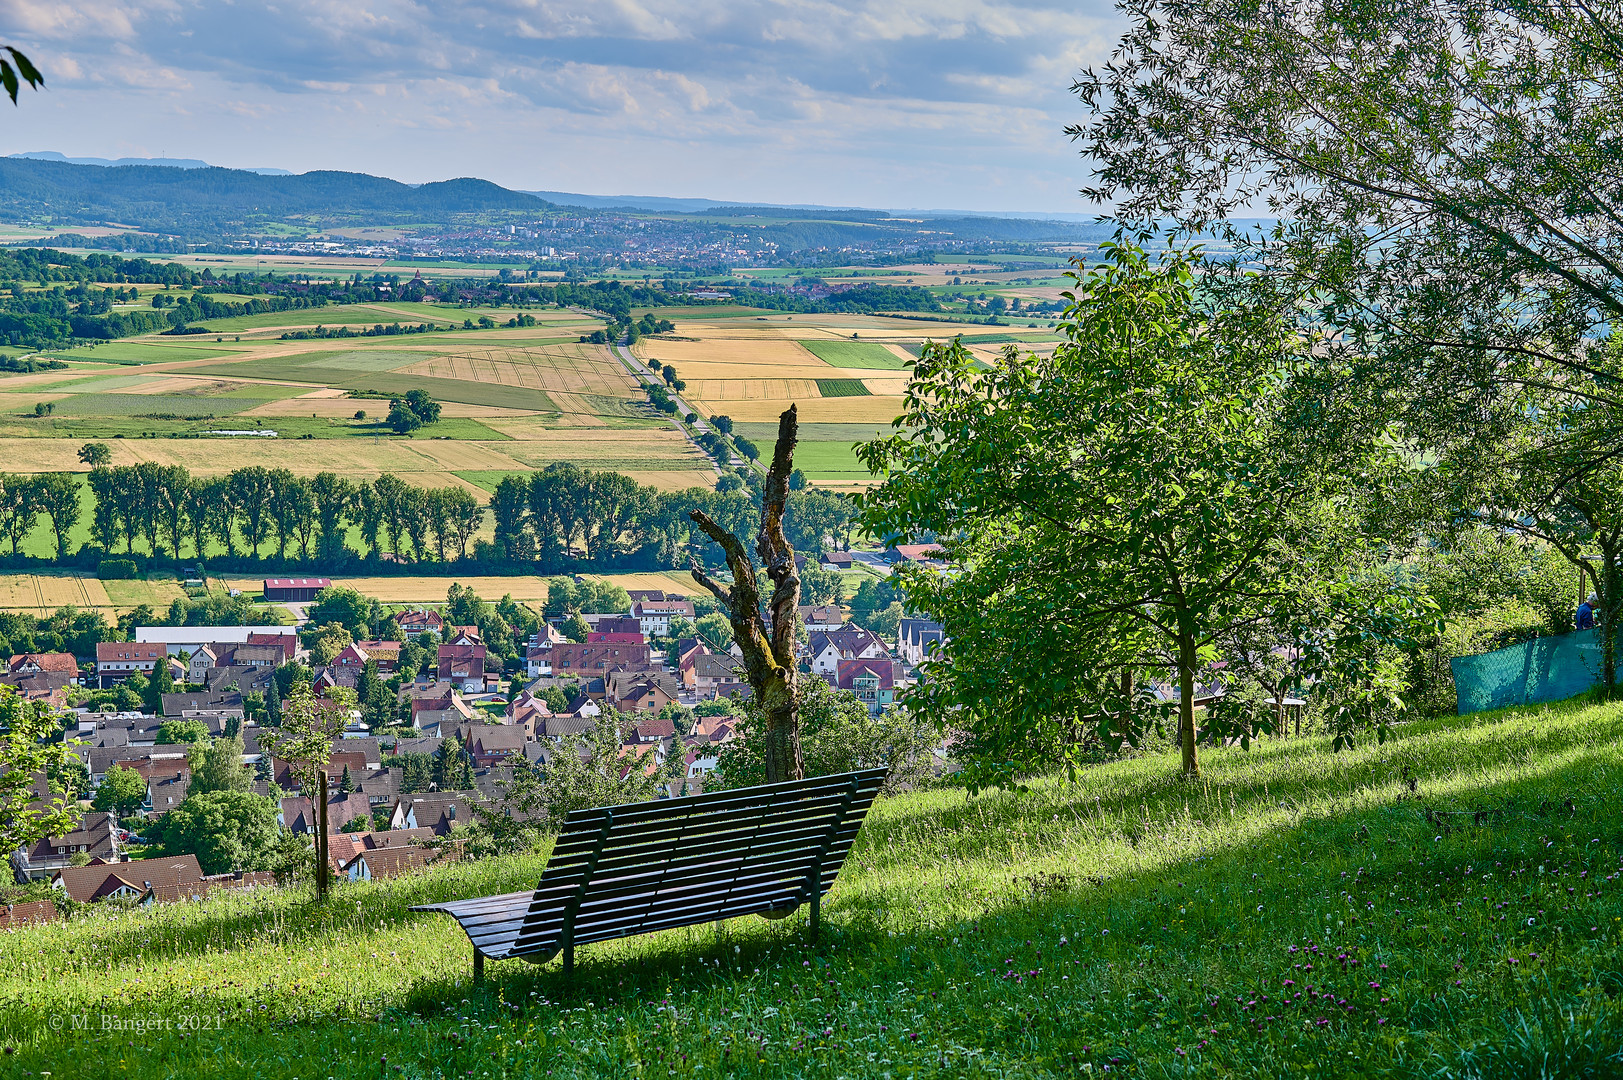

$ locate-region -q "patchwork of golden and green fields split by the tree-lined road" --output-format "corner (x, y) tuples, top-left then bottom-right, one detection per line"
(0, 302), (986, 506)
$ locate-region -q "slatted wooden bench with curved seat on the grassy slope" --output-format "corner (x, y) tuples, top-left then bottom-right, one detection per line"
(412, 768), (888, 981)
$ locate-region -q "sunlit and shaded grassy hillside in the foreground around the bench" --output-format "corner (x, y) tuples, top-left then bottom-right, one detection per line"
(0, 705), (1623, 1080)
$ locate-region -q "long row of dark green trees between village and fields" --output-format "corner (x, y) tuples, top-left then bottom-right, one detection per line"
(0, 457), (852, 573)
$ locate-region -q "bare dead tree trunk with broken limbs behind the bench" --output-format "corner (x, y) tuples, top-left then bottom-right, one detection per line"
(690, 406), (805, 783)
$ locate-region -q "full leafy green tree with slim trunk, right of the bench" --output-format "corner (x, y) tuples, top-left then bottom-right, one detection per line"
(859, 245), (1408, 783)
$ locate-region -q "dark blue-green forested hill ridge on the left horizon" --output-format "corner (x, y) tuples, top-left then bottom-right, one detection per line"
(0, 158), (550, 235)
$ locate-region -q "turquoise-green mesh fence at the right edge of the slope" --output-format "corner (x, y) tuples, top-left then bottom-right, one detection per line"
(1448, 630), (1600, 715)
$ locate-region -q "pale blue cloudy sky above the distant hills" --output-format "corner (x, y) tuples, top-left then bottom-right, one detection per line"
(0, 0), (1121, 213)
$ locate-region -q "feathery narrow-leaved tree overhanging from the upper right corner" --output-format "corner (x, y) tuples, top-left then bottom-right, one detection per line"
(1070, 0), (1623, 636)
